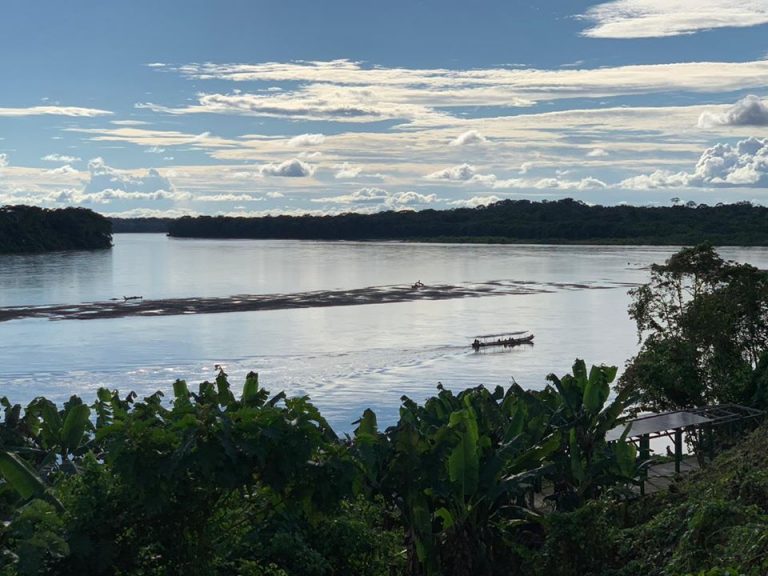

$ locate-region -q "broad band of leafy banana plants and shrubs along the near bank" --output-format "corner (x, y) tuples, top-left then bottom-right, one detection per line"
(0, 361), (635, 576)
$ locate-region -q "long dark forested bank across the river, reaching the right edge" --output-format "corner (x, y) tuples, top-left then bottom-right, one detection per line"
(158, 199), (768, 245)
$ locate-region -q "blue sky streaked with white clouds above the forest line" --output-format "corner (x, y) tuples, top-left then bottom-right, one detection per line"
(0, 0), (768, 217)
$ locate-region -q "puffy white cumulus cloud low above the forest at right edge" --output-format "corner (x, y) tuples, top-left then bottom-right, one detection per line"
(619, 138), (768, 189)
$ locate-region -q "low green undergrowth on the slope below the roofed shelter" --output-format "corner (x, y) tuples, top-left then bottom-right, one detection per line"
(523, 426), (768, 576)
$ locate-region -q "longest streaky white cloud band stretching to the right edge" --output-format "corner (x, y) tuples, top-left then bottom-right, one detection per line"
(136, 58), (768, 127)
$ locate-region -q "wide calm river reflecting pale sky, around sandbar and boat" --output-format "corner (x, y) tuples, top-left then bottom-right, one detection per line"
(0, 234), (768, 432)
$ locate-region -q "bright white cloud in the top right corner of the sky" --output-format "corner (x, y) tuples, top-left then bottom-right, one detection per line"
(584, 0), (768, 38)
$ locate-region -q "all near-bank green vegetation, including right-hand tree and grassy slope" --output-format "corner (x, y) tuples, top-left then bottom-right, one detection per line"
(0, 246), (768, 576)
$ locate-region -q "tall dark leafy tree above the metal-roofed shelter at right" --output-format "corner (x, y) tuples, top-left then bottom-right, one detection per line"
(620, 244), (768, 410)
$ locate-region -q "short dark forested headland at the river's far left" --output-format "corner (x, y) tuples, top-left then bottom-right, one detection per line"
(0, 206), (112, 254)
